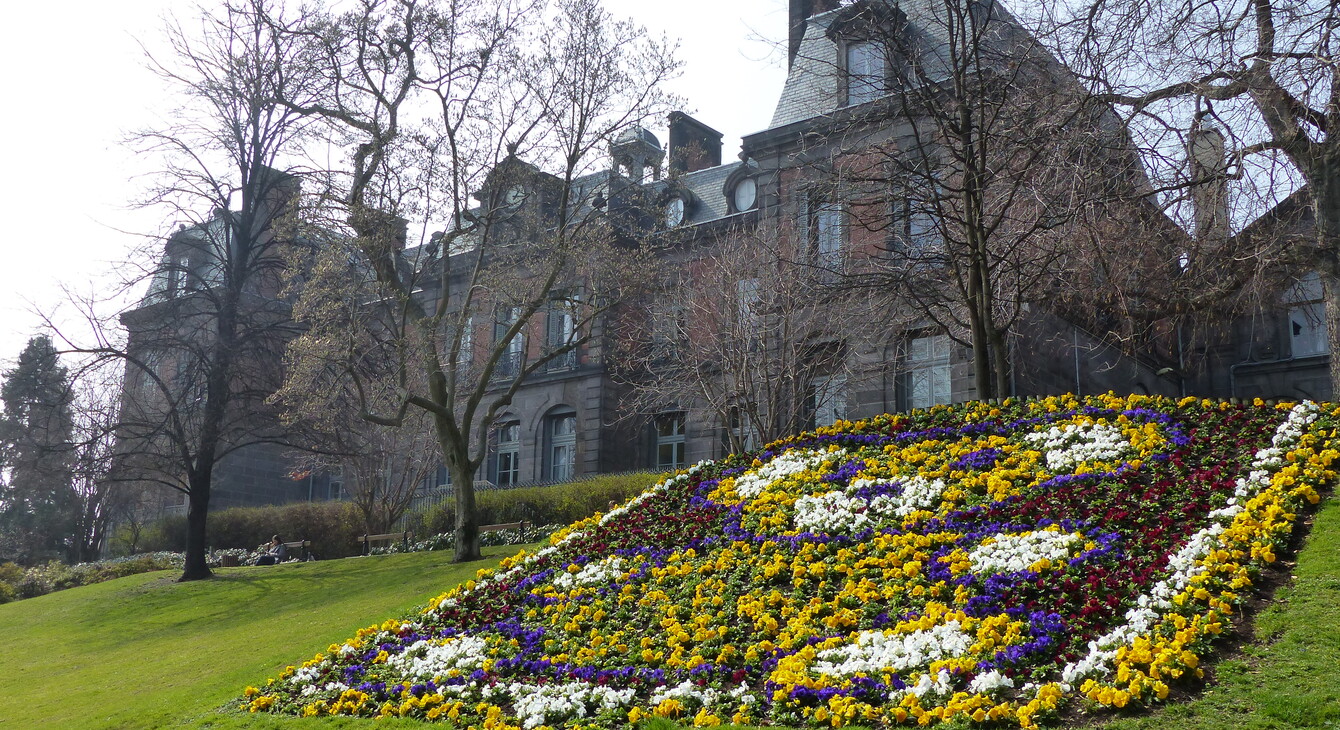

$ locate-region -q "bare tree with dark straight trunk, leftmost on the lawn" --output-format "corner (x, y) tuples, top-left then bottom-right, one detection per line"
(62, 0), (329, 580)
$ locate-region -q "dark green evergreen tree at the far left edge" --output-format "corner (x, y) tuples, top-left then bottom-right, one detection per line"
(0, 335), (75, 563)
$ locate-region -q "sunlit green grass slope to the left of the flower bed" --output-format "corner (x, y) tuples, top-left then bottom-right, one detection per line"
(0, 548), (517, 729)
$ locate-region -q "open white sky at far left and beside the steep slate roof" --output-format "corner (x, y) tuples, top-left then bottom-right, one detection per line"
(0, 0), (787, 363)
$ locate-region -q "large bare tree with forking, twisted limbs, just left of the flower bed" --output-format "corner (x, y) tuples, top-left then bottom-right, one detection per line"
(270, 0), (675, 560)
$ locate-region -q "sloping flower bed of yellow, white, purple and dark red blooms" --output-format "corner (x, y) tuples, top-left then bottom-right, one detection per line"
(241, 396), (1340, 729)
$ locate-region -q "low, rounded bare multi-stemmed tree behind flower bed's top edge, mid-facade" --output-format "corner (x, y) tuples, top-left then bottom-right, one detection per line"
(618, 226), (875, 451)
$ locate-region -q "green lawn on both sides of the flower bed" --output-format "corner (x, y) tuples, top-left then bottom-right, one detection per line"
(0, 497), (1340, 730)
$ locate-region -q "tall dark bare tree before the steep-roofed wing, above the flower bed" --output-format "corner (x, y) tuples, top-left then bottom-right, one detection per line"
(791, 0), (1175, 398)
